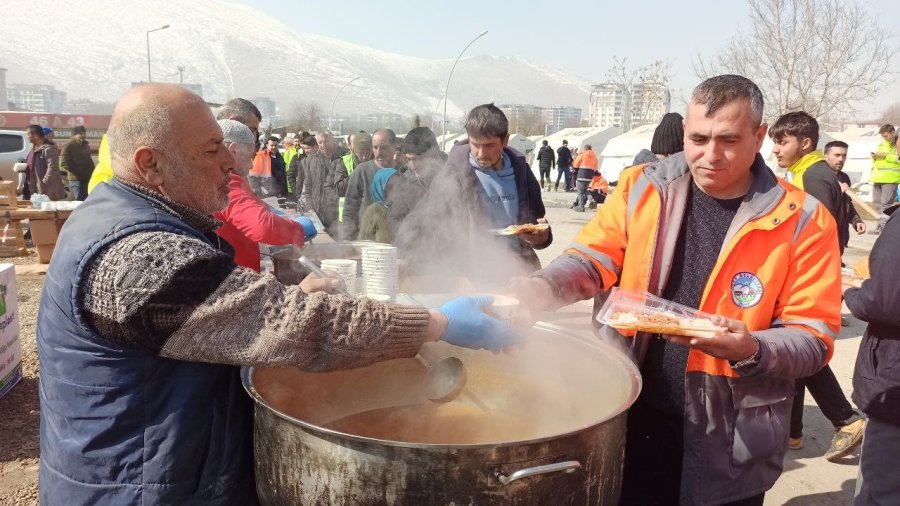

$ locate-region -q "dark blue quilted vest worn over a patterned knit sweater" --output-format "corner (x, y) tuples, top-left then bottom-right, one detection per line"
(37, 181), (256, 506)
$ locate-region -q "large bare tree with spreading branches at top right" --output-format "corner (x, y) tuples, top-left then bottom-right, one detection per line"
(694, 0), (895, 118)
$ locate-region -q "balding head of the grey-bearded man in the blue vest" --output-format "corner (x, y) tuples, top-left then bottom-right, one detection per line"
(107, 84), (234, 214)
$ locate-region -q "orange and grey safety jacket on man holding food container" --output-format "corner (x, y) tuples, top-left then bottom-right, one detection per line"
(535, 154), (841, 505)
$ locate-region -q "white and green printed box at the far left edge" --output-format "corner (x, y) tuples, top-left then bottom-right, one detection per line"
(0, 264), (22, 397)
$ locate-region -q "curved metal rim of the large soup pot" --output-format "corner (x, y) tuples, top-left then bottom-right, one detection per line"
(241, 322), (642, 450)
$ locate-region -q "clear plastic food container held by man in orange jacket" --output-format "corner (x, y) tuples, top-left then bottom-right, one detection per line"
(597, 288), (727, 338)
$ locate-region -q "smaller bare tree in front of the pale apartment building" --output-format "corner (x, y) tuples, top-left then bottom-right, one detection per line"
(606, 56), (672, 130)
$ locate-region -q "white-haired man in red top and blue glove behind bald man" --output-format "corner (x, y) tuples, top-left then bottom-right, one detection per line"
(214, 119), (316, 271)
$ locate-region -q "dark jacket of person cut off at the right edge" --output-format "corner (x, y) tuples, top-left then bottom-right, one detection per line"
(844, 215), (900, 426)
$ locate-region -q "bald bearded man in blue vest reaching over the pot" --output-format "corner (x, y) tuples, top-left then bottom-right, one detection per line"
(37, 84), (517, 506)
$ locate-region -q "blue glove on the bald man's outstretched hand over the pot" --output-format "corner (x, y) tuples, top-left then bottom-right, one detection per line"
(438, 297), (520, 351)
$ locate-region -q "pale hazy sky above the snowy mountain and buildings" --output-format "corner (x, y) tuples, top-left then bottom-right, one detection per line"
(238, 0), (900, 115)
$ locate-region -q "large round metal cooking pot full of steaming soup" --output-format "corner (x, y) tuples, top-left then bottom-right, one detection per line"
(242, 323), (640, 505)
